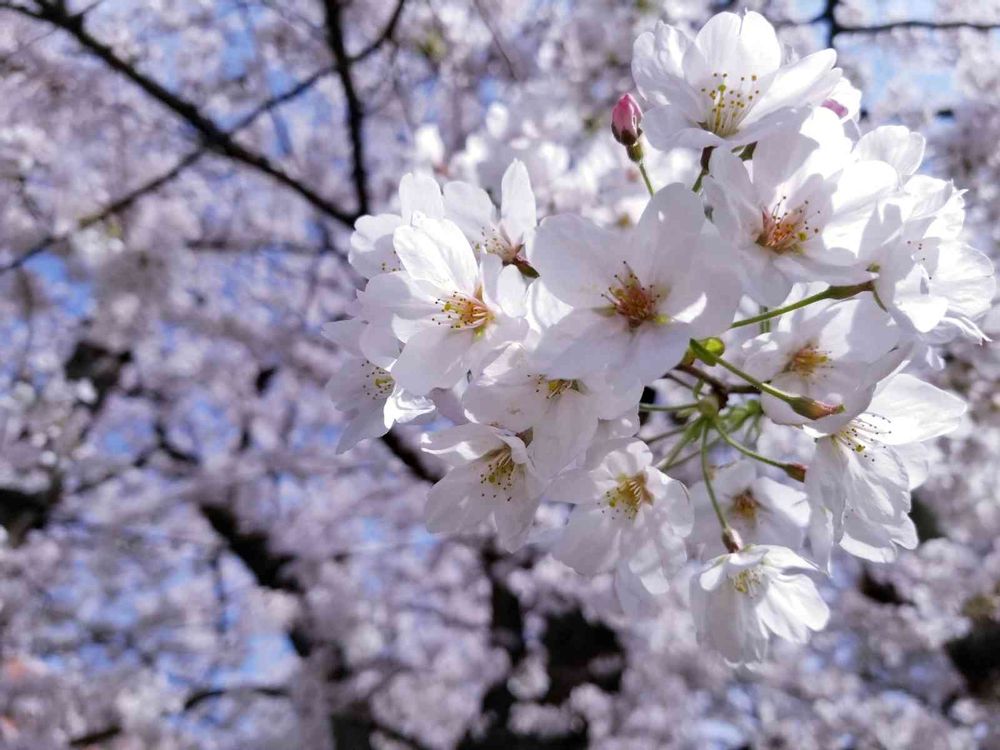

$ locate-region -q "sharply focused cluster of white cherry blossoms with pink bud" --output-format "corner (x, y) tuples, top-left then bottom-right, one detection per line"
(329, 12), (994, 664)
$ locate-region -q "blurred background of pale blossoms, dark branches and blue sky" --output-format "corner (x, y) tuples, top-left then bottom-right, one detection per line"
(0, 0), (1000, 750)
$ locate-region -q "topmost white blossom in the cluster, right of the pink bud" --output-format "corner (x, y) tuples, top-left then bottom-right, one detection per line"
(632, 11), (841, 150)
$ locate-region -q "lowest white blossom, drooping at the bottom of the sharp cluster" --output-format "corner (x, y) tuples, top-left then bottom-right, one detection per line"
(691, 544), (830, 665)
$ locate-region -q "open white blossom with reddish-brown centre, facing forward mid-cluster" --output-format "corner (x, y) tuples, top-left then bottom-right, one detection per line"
(529, 185), (737, 389)
